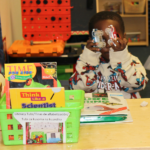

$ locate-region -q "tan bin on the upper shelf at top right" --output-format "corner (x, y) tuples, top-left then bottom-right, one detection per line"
(124, 0), (145, 14)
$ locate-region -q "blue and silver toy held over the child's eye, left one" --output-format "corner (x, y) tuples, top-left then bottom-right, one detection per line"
(92, 29), (106, 48)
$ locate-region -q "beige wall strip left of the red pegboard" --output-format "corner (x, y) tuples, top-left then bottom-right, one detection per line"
(0, 0), (23, 49)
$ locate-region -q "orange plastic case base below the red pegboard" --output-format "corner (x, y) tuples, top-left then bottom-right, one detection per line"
(7, 40), (65, 57)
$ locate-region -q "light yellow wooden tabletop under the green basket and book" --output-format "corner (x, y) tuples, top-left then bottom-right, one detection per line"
(0, 98), (150, 150)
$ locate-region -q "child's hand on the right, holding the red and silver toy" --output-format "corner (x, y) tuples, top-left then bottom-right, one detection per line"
(111, 38), (128, 51)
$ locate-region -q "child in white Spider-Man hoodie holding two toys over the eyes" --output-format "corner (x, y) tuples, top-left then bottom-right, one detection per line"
(69, 11), (148, 99)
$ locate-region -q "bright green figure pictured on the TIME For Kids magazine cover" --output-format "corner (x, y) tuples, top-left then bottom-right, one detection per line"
(24, 79), (50, 88)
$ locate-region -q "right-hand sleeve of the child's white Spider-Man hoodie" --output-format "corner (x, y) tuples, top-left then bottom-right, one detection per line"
(110, 47), (148, 93)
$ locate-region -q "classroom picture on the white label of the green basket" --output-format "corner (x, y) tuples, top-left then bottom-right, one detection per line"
(26, 122), (63, 143)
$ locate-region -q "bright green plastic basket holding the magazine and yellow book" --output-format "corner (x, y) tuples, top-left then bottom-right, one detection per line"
(0, 90), (84, 145)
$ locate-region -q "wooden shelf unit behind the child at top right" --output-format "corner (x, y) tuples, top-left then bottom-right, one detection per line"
(96, 0), (149, 46)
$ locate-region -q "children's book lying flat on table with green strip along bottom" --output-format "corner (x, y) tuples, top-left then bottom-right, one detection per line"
(80, 93), (133, 124)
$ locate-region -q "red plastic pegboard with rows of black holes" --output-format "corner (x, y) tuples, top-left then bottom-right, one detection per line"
(21, 0), (71, 41)
